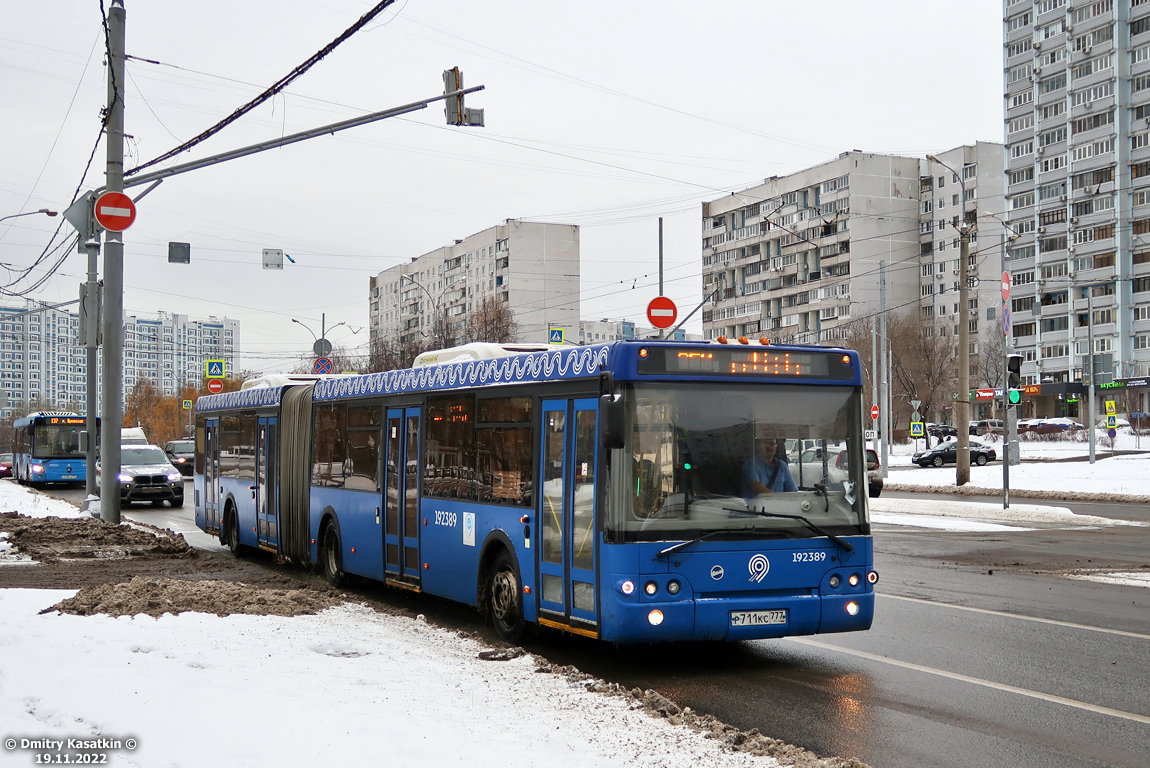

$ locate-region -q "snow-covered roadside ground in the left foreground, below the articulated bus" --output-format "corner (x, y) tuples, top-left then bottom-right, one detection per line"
(0, 590), (846, 768)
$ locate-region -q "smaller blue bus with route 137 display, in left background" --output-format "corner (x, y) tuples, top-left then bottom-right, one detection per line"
(12, 412), (100, 485)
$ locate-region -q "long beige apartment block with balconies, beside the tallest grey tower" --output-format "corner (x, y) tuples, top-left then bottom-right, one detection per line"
(703, 143), (1002, 354)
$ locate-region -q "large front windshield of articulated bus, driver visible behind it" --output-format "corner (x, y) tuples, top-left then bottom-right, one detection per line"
(606, 384), (868, 540)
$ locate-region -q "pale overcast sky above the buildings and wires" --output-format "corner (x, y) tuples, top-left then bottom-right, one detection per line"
(0, 0), (1003, 371)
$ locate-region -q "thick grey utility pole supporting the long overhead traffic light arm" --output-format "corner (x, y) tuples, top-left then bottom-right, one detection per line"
(100, 0), (127, 525)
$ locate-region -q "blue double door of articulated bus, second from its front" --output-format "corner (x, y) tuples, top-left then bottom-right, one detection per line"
(383, 408), (420, 583)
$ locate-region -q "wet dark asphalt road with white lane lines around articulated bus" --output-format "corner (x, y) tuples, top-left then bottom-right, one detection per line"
(35, 492), (1150, 768)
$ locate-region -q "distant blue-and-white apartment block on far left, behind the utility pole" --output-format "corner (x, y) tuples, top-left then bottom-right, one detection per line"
(0, 301), (239, 416)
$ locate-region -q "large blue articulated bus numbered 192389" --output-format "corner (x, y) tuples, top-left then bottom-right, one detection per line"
(194, 341), (877, 643)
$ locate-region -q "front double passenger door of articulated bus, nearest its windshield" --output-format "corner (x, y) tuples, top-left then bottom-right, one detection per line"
(538, 398), (599, 624)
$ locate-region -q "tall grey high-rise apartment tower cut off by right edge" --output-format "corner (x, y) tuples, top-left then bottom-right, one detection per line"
(1003, 0), (1150, 416)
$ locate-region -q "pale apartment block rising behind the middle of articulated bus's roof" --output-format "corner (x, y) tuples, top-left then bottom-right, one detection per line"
(369, 218), (580, 346)
